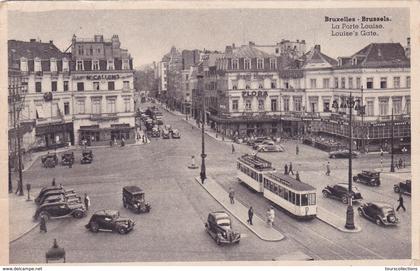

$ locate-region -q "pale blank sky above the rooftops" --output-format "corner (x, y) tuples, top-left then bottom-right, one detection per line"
(8, 8), (410, 67)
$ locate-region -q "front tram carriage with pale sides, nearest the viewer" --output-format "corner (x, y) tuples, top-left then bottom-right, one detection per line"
(263, 172), (316, 219)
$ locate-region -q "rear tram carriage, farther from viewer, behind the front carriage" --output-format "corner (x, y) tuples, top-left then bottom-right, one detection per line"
(236, 154), (276, 193)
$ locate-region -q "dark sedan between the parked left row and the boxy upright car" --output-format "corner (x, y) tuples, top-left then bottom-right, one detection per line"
(85, 210), (135, 234)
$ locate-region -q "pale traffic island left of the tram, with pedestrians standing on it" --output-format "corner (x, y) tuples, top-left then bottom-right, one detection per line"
(195, 177), (284, 242)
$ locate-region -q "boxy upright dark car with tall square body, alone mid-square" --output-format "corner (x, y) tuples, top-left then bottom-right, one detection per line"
(123, 185), (151, 214)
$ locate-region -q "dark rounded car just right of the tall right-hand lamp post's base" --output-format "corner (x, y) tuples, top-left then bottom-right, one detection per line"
(357, 202), (398, 226)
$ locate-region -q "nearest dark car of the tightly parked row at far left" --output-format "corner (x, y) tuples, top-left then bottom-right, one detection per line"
(33, 202), (86, 220)
